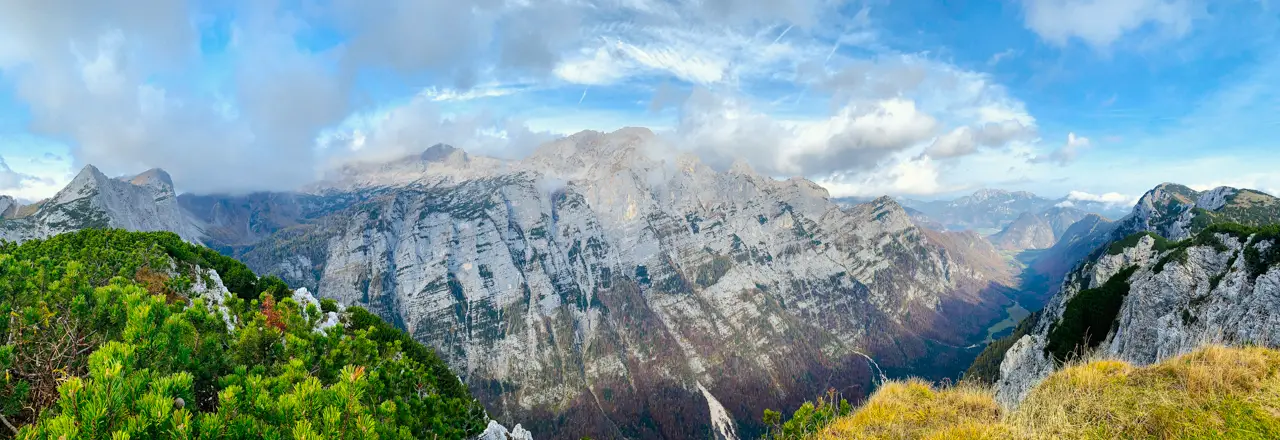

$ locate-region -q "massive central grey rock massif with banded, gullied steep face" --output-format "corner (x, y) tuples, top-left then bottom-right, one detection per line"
(242, 129), (1009, 437)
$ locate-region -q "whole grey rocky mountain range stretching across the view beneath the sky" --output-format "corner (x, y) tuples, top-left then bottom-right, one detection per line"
(0, 128), (1280, 439)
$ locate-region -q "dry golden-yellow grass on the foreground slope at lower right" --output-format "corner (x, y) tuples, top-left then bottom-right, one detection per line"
(815, 347), (1280, 440)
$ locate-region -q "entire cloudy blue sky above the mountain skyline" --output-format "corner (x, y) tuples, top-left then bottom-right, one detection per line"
(0, 0), (1280, 203)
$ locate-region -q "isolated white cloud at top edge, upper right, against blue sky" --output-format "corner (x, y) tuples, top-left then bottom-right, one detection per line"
(1023, 0), (1197, 49)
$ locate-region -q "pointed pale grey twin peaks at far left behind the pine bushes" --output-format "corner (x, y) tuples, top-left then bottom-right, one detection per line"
(0, 165), (201, 242)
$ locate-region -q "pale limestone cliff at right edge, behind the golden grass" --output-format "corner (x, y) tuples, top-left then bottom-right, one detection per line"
(997, 184), (1280, 404)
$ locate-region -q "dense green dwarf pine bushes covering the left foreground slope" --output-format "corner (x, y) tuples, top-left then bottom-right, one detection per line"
(0, 230), (488, 440)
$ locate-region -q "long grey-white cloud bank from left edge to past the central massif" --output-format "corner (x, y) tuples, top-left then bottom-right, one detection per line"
(0, 0), (1059, 200)
